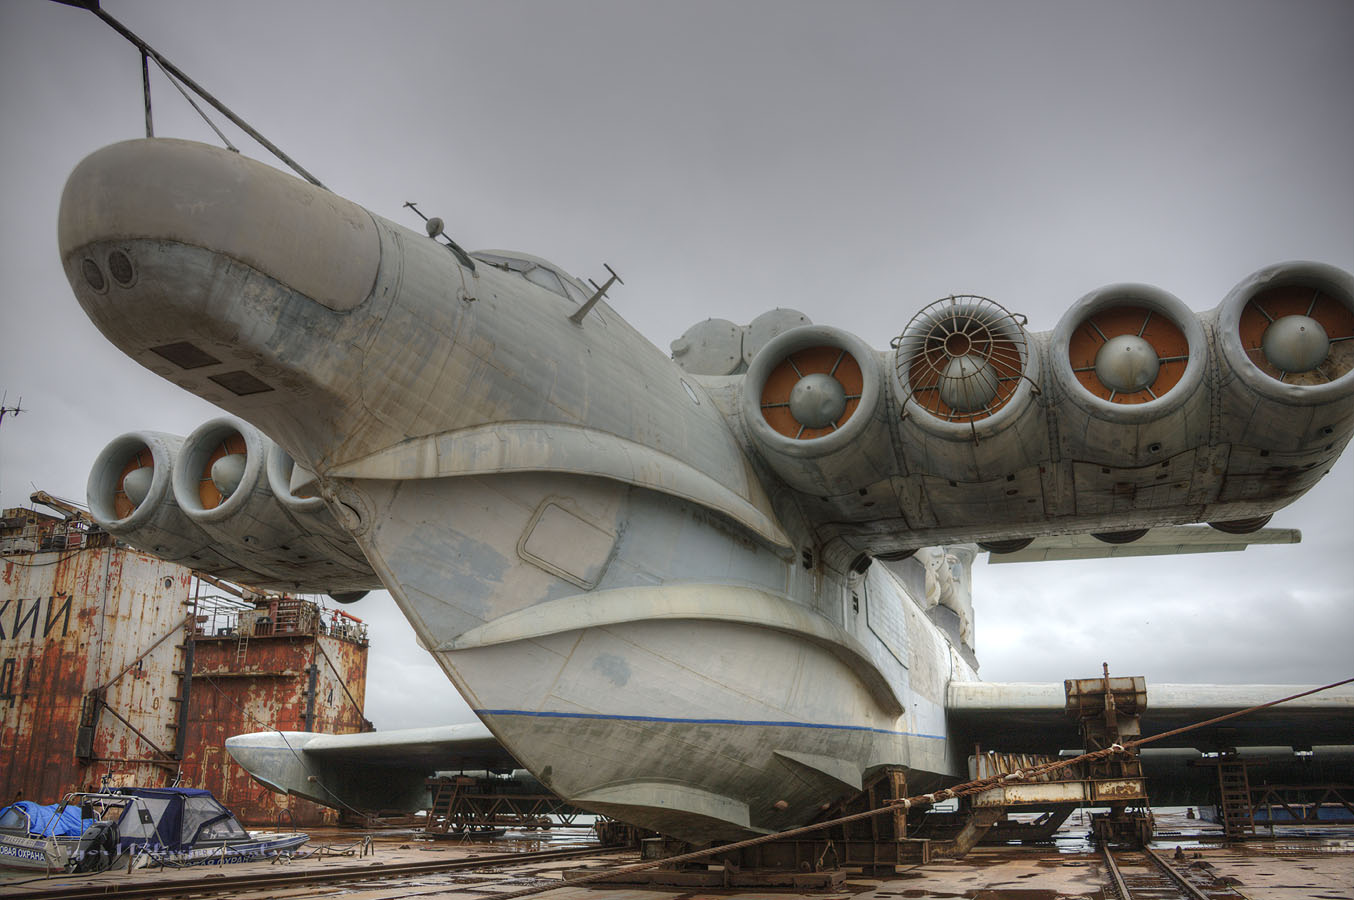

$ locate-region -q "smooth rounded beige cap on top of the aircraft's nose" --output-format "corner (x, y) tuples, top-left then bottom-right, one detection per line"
(58, 138), (380, 311)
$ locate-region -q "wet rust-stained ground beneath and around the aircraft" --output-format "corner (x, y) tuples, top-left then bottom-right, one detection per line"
(0, 809), (1354, 900)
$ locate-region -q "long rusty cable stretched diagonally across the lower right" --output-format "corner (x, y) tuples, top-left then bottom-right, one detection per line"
(482, 678), (1354, 900)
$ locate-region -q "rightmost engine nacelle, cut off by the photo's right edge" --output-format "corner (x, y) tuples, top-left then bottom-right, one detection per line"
(1216, 263), (1354, 518)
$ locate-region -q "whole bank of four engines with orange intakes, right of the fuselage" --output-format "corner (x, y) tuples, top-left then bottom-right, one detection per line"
(704, 263), (1354, 562)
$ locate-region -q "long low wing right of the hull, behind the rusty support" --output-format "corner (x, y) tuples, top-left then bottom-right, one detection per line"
(946, 682), (1354, 754)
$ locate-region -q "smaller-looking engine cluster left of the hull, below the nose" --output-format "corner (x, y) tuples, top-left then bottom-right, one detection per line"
(87, 418), (380, 601)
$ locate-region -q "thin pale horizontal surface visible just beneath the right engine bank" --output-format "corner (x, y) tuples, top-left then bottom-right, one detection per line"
(987, 525), (1303, 563)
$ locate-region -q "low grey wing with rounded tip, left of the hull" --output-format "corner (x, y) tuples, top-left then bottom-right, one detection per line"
(226, 721), (521, 811)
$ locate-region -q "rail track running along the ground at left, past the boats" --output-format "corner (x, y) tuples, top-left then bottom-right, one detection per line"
(0, 846), (623, 900)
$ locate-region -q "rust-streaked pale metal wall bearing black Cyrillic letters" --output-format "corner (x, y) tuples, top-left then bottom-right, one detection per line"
(0, 547), (191, 803)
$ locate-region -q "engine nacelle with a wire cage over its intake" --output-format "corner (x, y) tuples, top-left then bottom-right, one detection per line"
(894, 296), (1048, 487)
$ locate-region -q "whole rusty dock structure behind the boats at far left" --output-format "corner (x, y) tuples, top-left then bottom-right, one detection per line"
(0, 500), (371, 826)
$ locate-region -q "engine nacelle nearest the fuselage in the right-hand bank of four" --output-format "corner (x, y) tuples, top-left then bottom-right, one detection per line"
(741, 325), (896, 497)
